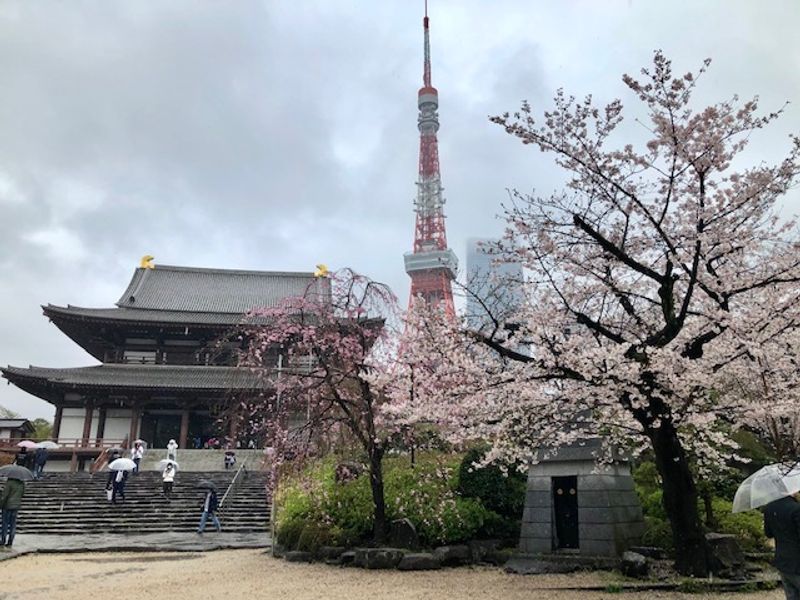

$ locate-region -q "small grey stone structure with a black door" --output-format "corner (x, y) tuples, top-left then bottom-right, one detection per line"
(519, 444), (644, 556)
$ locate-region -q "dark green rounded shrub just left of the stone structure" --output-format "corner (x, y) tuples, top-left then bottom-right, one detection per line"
(458, 448), (527, 519)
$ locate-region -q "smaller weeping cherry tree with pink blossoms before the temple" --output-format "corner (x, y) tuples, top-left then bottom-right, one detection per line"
(239, 269), (399, 541)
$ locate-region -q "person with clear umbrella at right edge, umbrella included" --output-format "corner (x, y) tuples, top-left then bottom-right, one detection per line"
(733, 464), (800, 600)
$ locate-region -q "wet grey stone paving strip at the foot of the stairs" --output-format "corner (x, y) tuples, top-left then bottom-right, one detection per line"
(0, 525), (271, 561)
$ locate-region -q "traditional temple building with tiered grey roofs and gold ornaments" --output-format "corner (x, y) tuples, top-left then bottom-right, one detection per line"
(0, 257), (330, 448)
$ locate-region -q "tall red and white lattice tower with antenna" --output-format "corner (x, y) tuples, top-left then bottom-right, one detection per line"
(404, 0), (458, 316)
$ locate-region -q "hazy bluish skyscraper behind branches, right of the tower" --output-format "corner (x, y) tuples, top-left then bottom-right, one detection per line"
(467, 238), (523, 330)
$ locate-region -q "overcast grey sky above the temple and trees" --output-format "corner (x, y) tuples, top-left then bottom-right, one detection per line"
(0, 0), (800, 418)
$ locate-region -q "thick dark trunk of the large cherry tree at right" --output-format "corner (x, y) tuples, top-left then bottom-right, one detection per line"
(650, 420), (709, 577)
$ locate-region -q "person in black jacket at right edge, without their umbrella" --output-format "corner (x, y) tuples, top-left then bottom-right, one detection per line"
(764, 494), (800, 600)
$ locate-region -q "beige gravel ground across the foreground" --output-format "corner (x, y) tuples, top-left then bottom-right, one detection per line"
(0, 550), (783, 600)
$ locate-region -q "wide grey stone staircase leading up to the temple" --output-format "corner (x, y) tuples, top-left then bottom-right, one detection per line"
(0, 470), (270, 535)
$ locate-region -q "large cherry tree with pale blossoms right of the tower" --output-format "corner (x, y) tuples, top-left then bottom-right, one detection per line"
(404, 52), (800, 575)
